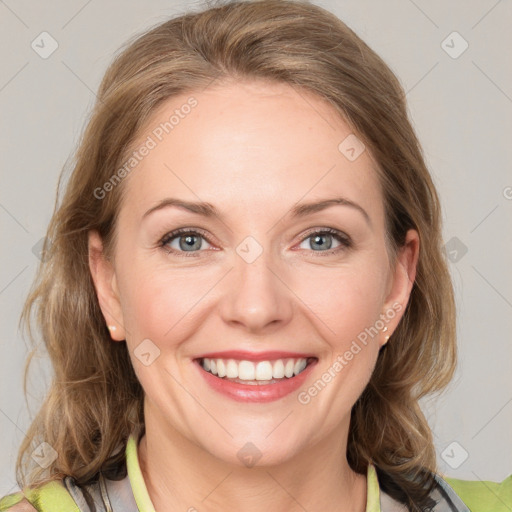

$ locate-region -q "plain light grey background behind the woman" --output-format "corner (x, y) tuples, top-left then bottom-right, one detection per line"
(0, 0), (512, 496)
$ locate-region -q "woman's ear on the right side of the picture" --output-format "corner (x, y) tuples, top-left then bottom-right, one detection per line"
(380, 229), (420, 346)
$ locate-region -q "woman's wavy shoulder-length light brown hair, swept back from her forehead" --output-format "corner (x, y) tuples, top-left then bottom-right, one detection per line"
(12, 0), (456, 511)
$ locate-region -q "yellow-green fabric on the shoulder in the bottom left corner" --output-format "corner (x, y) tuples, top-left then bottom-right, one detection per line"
(0, 480), (79, 512)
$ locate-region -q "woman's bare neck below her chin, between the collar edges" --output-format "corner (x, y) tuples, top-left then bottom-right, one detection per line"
(138, 404), (367, 512)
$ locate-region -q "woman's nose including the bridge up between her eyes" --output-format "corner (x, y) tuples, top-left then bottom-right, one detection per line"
(222, 236), (292, 331)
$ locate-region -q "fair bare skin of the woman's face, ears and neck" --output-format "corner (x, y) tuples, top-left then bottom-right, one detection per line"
(89, 81), (419, 512)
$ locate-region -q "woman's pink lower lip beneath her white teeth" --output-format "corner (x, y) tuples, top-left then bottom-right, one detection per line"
(194, 359), (317, 402)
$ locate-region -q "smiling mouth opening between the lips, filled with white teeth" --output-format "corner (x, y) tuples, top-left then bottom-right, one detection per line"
(196, 357), (318, 386)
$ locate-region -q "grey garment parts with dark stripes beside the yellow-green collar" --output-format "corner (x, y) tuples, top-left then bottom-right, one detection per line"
(64, 474), (471, 512)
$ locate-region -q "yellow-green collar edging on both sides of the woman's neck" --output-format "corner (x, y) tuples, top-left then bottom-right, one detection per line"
(126, 434), (381, 512)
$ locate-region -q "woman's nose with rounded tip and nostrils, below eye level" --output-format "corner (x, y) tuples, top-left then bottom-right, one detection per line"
(220, 246), (293, 334)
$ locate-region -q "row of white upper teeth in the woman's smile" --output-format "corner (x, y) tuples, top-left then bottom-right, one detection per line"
(202, 357), (308, 381)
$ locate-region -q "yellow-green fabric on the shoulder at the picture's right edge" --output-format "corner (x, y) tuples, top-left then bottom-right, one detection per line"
(443, 474), (512, 512)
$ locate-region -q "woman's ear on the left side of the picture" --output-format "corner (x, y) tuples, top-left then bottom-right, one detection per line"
(89, 230), (126, 341)
